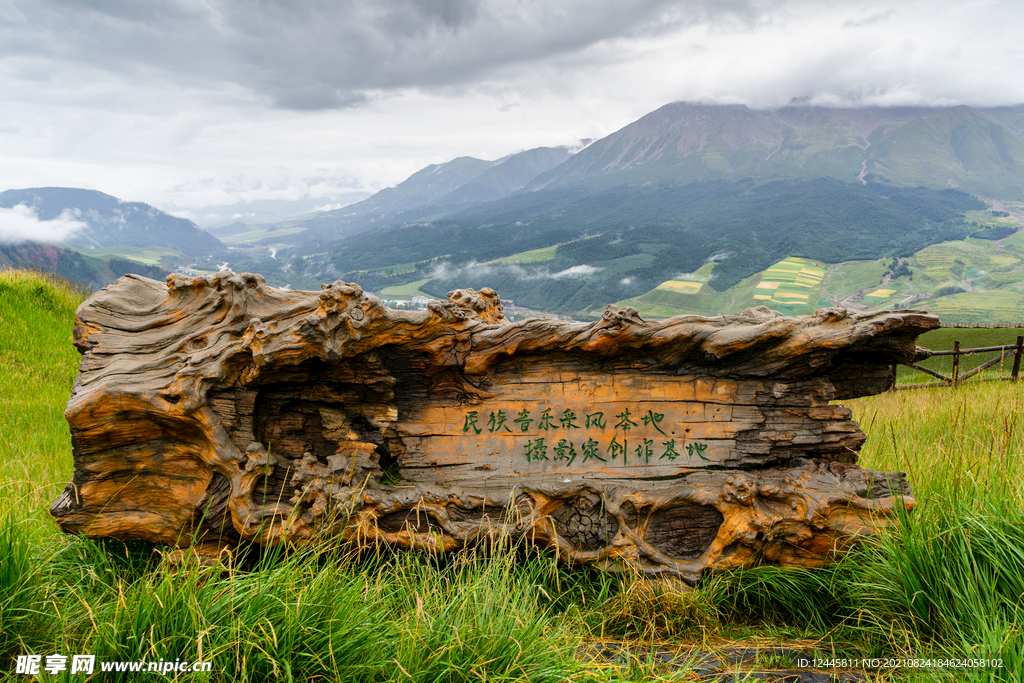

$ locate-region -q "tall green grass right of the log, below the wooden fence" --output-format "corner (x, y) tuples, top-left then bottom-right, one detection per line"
(853, 383), (1024, 680)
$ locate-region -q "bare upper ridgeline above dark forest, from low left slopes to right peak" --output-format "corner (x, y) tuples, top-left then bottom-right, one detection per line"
(235, 102), (1024, 253)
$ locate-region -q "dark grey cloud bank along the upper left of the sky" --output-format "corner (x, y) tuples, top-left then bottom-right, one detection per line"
(0, 0), (770, 110)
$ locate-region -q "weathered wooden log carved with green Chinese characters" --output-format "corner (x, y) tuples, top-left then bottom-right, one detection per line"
(50, 271), (938, 581)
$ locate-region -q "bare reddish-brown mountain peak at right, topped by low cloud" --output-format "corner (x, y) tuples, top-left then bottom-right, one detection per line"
(526, 102), (1024, 198)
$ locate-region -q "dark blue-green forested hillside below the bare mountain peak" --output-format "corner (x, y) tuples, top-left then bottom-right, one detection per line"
(293, 178), (984, 310)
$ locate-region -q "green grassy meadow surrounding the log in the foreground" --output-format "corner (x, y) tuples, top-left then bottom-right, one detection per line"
(0, 271), (1024, 682)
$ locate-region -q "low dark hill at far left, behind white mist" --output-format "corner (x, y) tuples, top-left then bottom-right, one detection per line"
(0, 187), (224, 256)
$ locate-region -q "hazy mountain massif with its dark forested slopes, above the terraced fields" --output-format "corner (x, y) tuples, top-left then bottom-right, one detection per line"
(218, 102), (1024, 321)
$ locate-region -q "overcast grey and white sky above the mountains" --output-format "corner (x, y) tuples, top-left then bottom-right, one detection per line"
(0, 0), (1024, 218)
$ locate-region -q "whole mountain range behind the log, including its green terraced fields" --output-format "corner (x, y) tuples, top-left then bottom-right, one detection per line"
(0, 102), (1024, 325)
